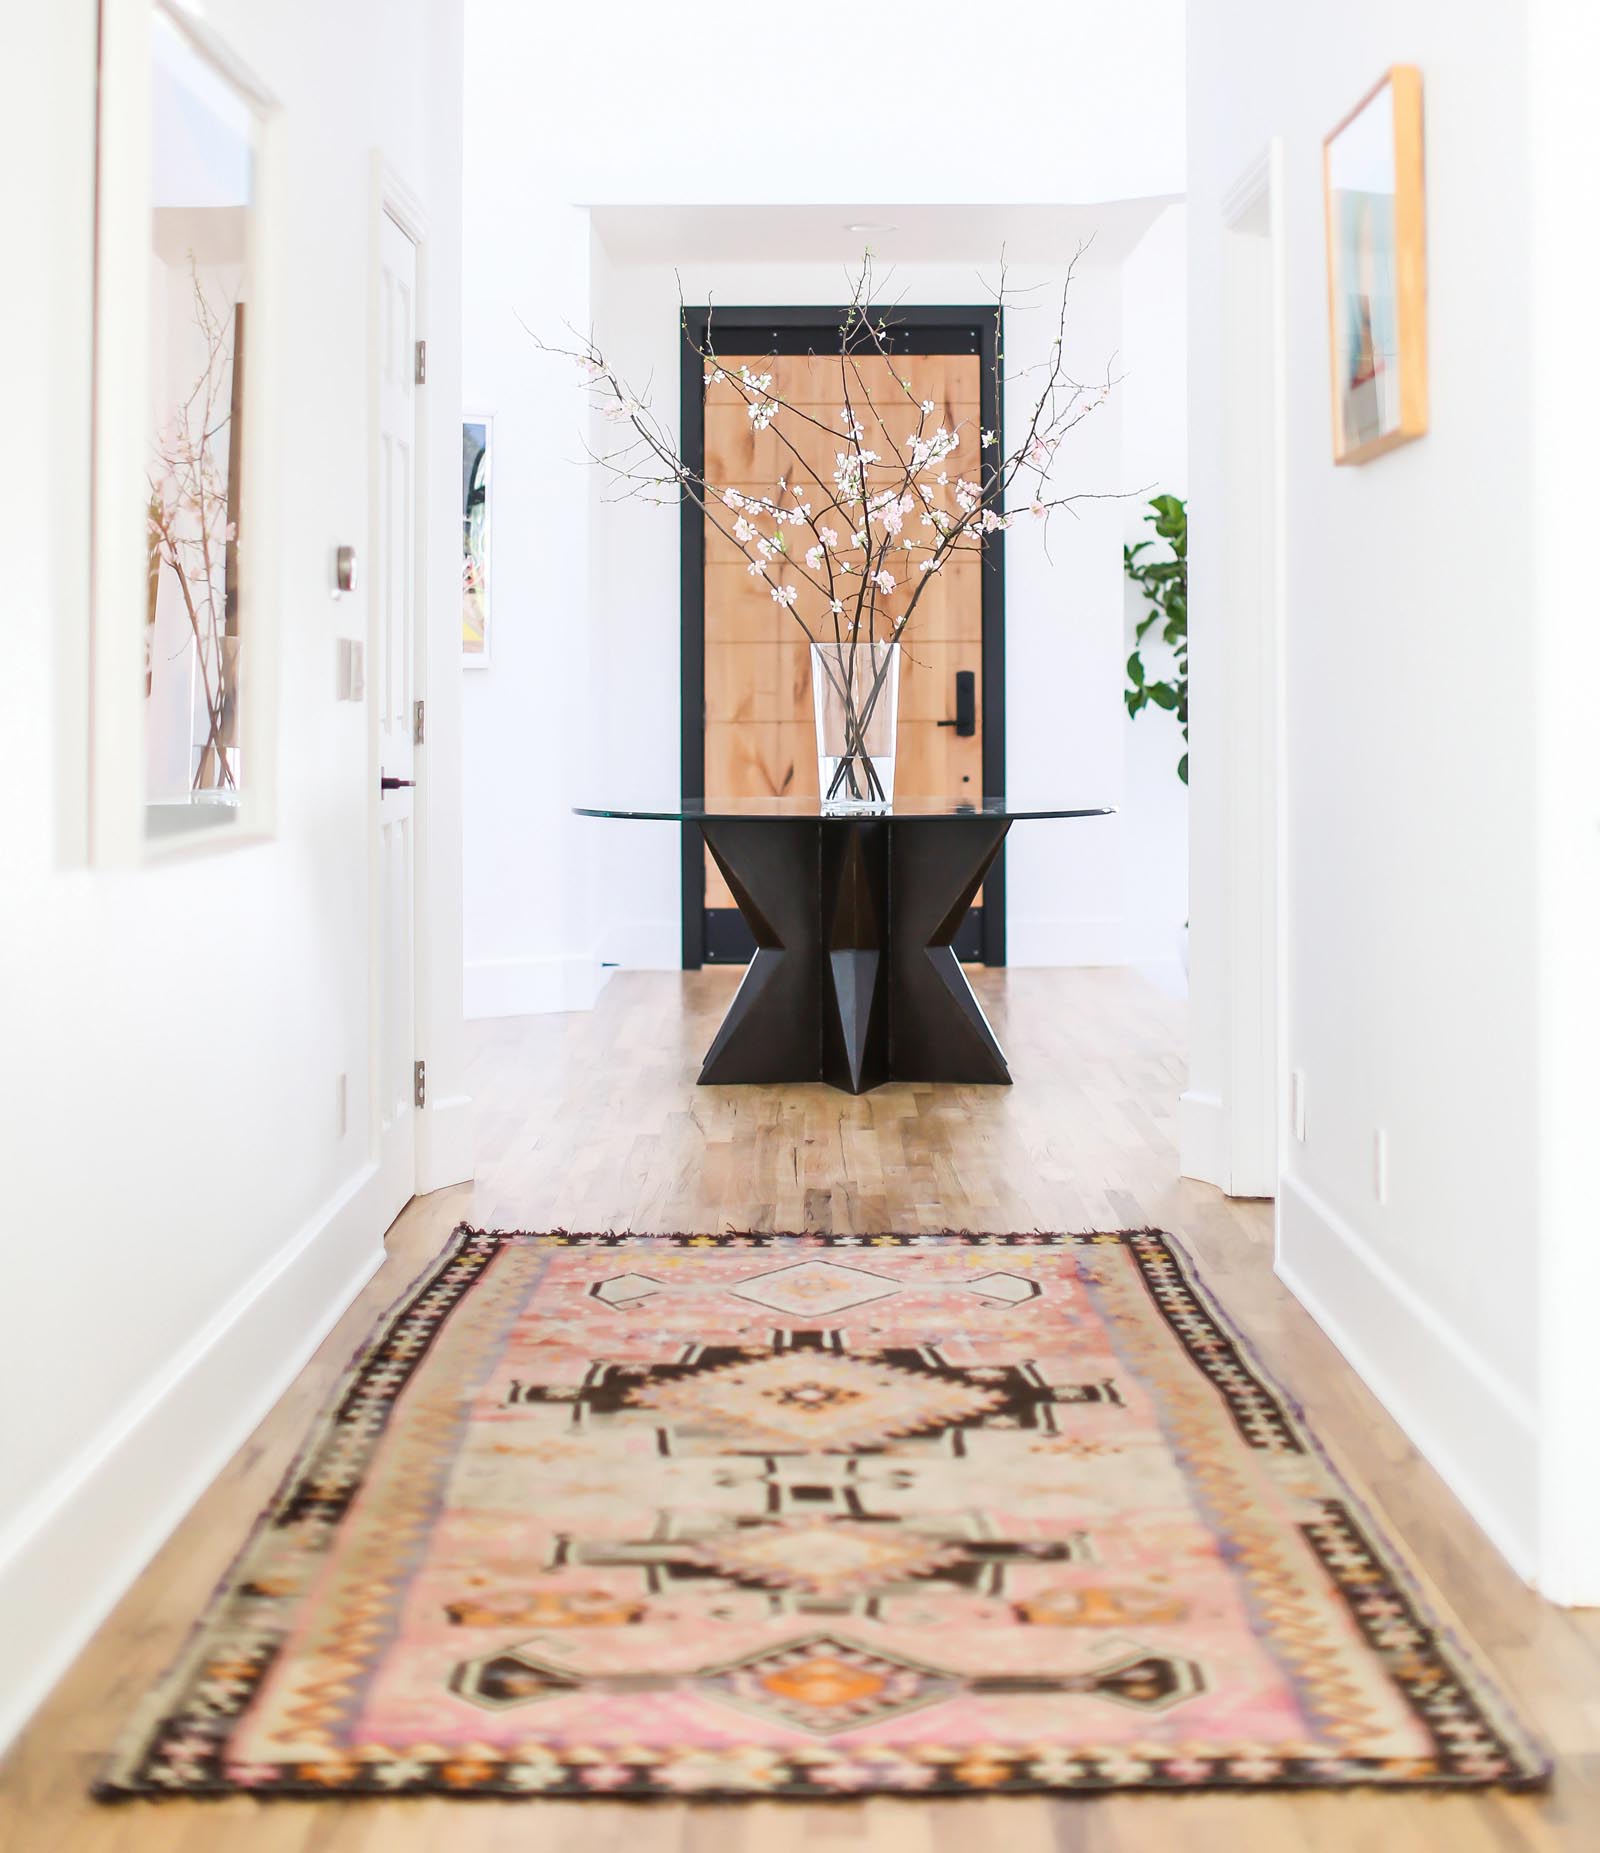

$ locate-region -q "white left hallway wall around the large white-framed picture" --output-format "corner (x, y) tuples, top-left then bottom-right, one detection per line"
(0, 0), (465, 1740)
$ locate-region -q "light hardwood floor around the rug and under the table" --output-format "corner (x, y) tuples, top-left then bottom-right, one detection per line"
(0, 971), (1600, 1853)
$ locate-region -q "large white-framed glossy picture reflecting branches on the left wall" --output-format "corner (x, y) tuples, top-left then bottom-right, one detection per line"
(91, 0), (276, 862)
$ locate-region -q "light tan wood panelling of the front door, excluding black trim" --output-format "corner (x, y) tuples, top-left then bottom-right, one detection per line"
(705, 344), (983, 926)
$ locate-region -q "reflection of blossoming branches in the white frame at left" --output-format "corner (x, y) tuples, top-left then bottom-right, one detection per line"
(145, 258), (243, 791)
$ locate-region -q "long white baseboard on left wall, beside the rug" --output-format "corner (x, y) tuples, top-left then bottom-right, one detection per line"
(0, 1166), (384, 1749)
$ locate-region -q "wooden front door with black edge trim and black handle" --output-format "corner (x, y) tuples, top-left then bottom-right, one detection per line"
(684, 309), (1003, 964)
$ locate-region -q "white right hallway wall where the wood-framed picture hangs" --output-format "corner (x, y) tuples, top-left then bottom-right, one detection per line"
(1188, 0), (1542, 1568)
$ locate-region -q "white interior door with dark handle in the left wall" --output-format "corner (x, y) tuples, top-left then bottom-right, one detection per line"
(369, 213), (417, 1219)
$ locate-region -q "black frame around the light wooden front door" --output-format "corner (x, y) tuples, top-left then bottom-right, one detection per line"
(679, 304), (1005, 971)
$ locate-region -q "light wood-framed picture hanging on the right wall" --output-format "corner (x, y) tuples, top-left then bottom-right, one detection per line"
(1322, 65), (1428, 463)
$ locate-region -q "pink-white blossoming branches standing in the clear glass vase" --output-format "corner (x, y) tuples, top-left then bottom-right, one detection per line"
(530, 252), (1114, 802)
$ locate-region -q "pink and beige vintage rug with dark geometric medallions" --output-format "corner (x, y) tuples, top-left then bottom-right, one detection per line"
(98, 1229), (1546, 1799)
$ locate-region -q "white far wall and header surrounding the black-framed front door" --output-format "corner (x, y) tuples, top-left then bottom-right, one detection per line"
(463, 0), (1183, 1015)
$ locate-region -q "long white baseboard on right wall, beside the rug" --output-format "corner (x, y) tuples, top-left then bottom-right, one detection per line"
(1277, 1177), (1539, 1582)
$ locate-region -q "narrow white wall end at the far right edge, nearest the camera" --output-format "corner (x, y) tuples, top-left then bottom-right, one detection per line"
(1528, 0), (1600, 1607)
